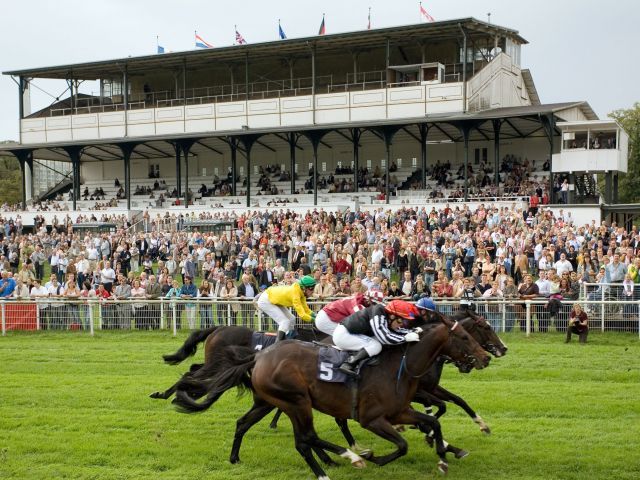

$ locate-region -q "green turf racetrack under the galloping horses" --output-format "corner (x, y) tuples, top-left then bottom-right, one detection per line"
(0, 332), (640, 480)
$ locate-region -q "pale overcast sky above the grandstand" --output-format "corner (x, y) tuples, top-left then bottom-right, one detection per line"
(0, 0), (640, 141)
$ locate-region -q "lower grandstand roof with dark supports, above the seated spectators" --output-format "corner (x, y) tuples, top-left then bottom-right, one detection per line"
(0, 101), (598, 162)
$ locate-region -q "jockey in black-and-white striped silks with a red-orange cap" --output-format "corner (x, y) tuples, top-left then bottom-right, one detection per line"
(333, 300), (422, 375)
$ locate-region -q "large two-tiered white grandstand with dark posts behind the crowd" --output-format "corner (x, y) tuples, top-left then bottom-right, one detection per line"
(1, 18), (627, 221)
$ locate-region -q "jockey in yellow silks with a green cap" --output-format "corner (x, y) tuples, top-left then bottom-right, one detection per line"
(257, 275), (316, 342)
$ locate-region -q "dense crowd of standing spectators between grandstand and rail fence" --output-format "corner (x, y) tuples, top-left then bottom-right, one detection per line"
(0, 200), (640, 331)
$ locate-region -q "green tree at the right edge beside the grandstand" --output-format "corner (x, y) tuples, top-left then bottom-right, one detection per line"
(609, 102), (640, 203)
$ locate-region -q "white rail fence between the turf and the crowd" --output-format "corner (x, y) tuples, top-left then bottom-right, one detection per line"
(0, 297), (640, 336)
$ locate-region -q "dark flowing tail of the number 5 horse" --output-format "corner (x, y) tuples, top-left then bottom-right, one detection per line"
(173, 346), (256, 413)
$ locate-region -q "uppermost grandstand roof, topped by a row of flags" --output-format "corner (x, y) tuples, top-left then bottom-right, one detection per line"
(3, 18), (528, 80)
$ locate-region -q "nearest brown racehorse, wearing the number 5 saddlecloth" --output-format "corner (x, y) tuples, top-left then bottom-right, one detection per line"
(174, 314), (490, 479)
